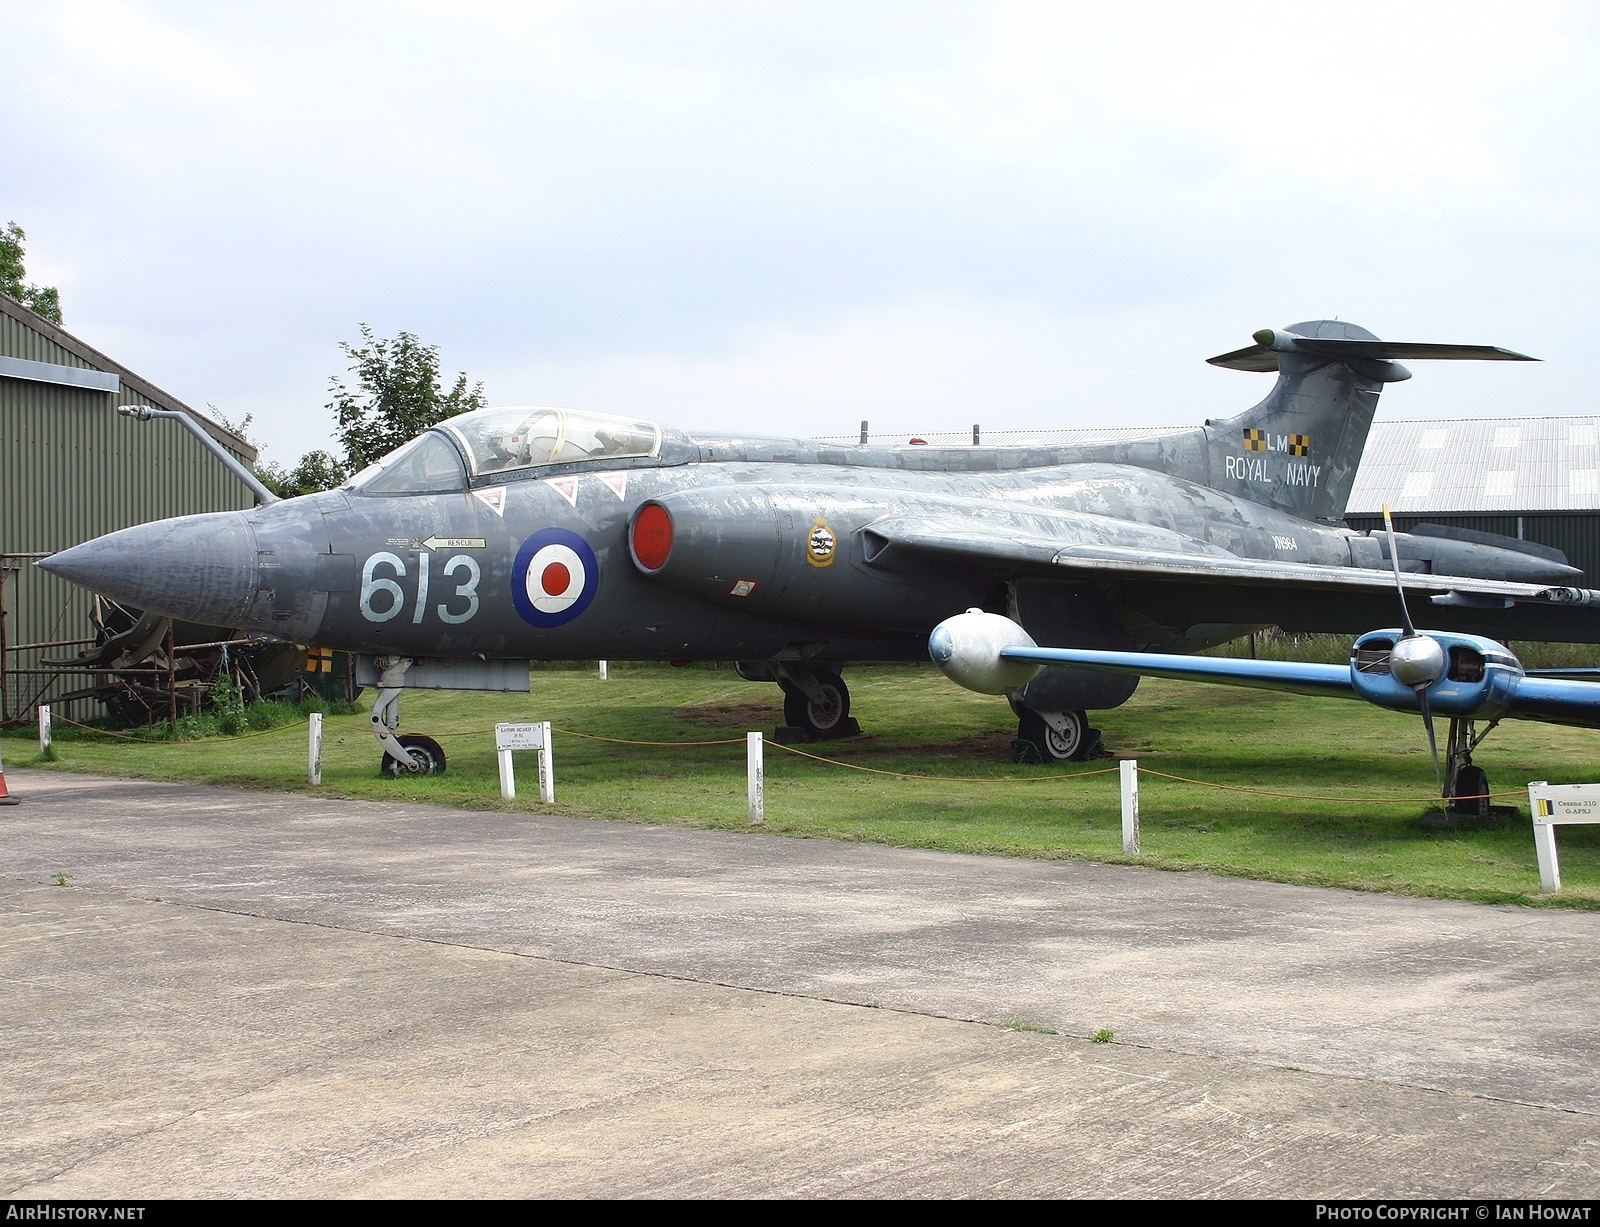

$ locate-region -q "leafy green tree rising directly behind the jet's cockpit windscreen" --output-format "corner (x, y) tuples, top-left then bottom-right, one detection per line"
(328, 323), (483, 472)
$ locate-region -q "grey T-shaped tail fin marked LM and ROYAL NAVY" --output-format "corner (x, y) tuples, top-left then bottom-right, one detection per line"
(1205, 320), (1536, 520)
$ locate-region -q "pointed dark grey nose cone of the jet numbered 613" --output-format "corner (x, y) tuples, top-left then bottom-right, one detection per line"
(38, 512), (256, 627)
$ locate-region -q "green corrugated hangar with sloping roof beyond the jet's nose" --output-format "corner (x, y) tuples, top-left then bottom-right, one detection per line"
(0, 294), (256, 723)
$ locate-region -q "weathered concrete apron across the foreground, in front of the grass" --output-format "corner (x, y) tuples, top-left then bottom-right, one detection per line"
(0, 771), (1600, 1197)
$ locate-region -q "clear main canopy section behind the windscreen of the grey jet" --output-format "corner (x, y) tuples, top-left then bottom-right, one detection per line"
(443, 406), (661, 477)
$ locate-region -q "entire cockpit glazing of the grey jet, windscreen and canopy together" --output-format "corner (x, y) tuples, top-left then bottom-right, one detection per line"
(350, 405), (662, 494)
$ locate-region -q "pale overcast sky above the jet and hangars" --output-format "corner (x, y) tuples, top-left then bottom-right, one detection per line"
(0, 0), (1600, 464)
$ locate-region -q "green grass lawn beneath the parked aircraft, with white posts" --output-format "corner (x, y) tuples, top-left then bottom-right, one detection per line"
(12, 664), (1600, 909)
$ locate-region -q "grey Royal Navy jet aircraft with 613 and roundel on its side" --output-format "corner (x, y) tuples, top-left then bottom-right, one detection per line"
(40, 320), (1600, 771)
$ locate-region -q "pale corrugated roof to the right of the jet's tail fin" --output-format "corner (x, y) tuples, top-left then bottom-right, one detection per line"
(1349, 416), (1600, 515)
